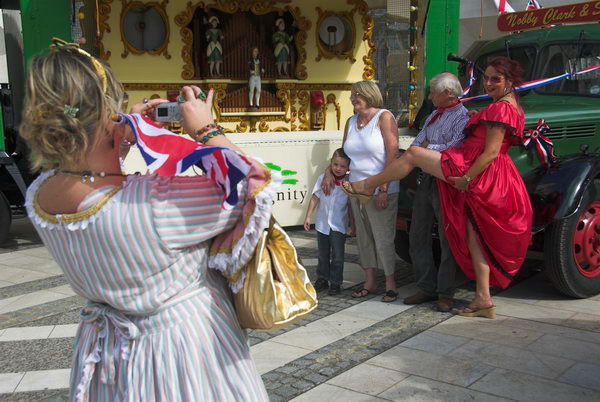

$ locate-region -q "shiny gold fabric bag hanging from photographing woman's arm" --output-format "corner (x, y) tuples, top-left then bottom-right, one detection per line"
(233, 218), (317, 330)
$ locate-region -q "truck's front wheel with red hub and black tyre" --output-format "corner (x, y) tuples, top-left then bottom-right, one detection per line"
(544, 180), (600, 298)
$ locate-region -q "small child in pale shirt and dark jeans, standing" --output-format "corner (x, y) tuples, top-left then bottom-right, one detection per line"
(304, 148), (350, 295)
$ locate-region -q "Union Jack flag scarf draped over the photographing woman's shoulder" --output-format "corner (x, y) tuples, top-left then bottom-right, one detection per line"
(119, 114), (251, 209)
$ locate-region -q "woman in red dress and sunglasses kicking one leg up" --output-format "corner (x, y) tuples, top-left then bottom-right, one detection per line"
(345, 57), (532, 318)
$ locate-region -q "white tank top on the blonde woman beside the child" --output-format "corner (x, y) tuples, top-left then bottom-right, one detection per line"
(344, 109), (400, 193)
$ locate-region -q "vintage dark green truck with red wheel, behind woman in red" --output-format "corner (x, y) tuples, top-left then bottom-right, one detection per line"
(396, 24), (600, 298)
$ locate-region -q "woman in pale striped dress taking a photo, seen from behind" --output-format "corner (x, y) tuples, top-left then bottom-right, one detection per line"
(21, 45), (275, 401)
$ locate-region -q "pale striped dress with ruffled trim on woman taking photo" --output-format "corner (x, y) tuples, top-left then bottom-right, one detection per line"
(27, 164), (277, 401)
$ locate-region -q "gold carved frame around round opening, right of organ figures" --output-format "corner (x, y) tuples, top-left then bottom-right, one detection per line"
(315, 7), (356, 63)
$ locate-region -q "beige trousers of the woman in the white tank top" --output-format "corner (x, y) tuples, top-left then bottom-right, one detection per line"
(350, 193), (398, 276)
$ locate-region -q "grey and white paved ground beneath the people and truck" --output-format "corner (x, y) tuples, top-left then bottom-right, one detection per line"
(0, 220), (600, 401)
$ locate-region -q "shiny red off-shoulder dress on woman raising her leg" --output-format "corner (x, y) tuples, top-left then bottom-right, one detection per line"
(437, 102), (532, 288)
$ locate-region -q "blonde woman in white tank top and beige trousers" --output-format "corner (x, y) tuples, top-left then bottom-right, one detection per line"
(323, 81), (399, 302)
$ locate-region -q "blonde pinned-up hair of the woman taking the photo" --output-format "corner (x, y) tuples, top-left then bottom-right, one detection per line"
(19, 44), (125, 170)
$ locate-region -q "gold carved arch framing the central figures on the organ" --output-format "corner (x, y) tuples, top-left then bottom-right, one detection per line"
(175, 0), (311, 80)
